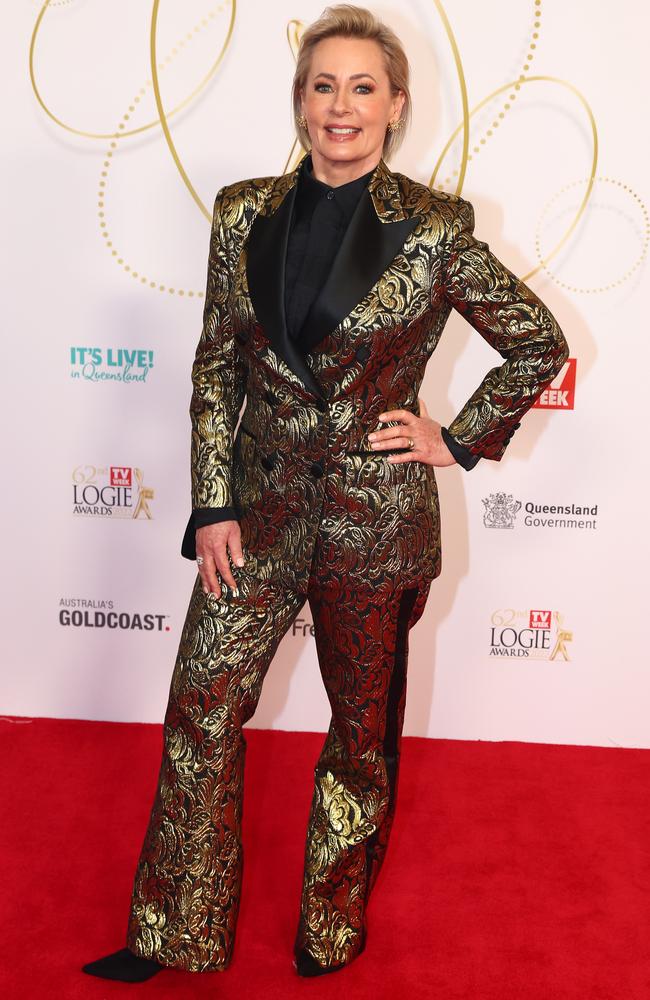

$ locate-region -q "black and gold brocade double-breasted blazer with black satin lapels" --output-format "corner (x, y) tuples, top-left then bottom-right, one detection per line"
(182, 151), (569, 589)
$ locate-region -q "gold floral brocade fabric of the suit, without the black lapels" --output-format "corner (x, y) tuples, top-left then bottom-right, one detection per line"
(127, 154), (568, 971)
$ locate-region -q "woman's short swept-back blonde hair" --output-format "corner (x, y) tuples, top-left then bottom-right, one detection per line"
(291, 3), (411, 159)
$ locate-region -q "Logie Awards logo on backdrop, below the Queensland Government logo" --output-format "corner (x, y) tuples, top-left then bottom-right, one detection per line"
(490, 608), (573, 661)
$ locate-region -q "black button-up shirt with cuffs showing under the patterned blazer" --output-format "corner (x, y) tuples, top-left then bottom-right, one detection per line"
(194, 153), (480, 528)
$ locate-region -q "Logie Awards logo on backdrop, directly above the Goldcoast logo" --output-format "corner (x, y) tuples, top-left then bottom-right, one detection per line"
(72, 465), (155, 520)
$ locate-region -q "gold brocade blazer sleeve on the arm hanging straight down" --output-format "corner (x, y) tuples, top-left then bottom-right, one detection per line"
(190, 188), (246, 512)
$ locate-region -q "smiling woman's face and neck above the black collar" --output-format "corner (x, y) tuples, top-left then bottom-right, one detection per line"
(301, 37), (404, 175)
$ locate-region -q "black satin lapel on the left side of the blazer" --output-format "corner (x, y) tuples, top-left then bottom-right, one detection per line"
(246, 184), (324, 398)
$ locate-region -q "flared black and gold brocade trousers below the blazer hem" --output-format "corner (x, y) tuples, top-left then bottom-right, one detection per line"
(127, 536), (430, 972)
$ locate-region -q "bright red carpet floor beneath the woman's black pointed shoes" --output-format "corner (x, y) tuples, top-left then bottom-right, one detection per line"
(0, 718), (650, 1000)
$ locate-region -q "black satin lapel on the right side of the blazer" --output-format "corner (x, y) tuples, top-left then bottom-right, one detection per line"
(298, 188), (420, 351)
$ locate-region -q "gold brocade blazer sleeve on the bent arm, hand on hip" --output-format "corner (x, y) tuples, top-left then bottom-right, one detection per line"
(443, 198), (569, 460)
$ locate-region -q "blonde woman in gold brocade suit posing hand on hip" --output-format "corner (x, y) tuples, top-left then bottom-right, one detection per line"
(84, 4), (568, 980)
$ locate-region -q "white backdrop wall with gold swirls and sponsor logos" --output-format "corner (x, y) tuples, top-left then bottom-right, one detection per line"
(0, 0), (650, 747)
